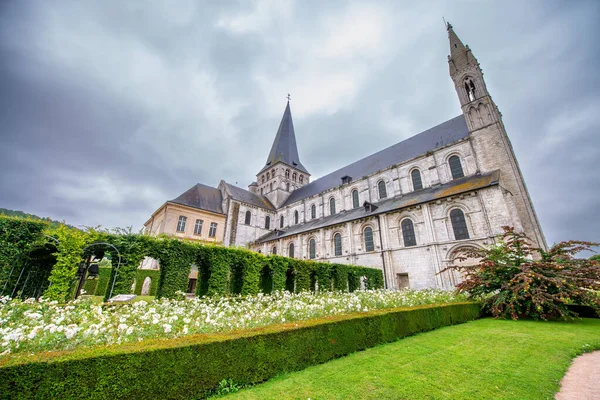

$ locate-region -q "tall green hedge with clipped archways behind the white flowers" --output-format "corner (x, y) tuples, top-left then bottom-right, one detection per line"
(0, 217), (383, 301)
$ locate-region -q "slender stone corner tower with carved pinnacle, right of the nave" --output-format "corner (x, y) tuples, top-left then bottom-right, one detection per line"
(447, 24), (546, 248)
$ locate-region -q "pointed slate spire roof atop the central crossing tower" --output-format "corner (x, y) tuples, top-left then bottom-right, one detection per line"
(259, 101), (310, 175)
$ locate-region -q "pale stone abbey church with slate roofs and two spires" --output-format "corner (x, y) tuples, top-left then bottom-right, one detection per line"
(145, 24), (546, 289)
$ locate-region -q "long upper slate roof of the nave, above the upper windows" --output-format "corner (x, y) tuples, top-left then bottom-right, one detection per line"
(282, 114), (469, 207)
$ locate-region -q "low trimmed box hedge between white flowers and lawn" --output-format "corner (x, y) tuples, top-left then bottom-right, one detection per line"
(0, 303), (481, 399)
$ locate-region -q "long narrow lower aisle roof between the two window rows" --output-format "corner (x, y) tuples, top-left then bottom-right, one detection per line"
(257, 170), (500, 243)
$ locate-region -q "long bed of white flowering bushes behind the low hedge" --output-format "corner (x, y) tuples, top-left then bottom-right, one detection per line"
(0, 290), (465, 356)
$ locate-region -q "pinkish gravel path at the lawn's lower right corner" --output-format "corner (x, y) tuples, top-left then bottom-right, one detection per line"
(556, 351), (600, 400)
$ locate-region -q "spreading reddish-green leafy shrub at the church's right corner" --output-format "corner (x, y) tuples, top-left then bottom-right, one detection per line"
(444, 227), (600, 320)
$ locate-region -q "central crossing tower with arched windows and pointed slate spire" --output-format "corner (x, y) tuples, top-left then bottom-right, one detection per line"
(255, 98), (310, 208)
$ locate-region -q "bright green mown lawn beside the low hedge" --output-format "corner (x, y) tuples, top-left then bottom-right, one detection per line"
(225, 318), (600, 399)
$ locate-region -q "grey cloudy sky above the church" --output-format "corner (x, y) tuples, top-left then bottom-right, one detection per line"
(0, 0), (600, 247)
